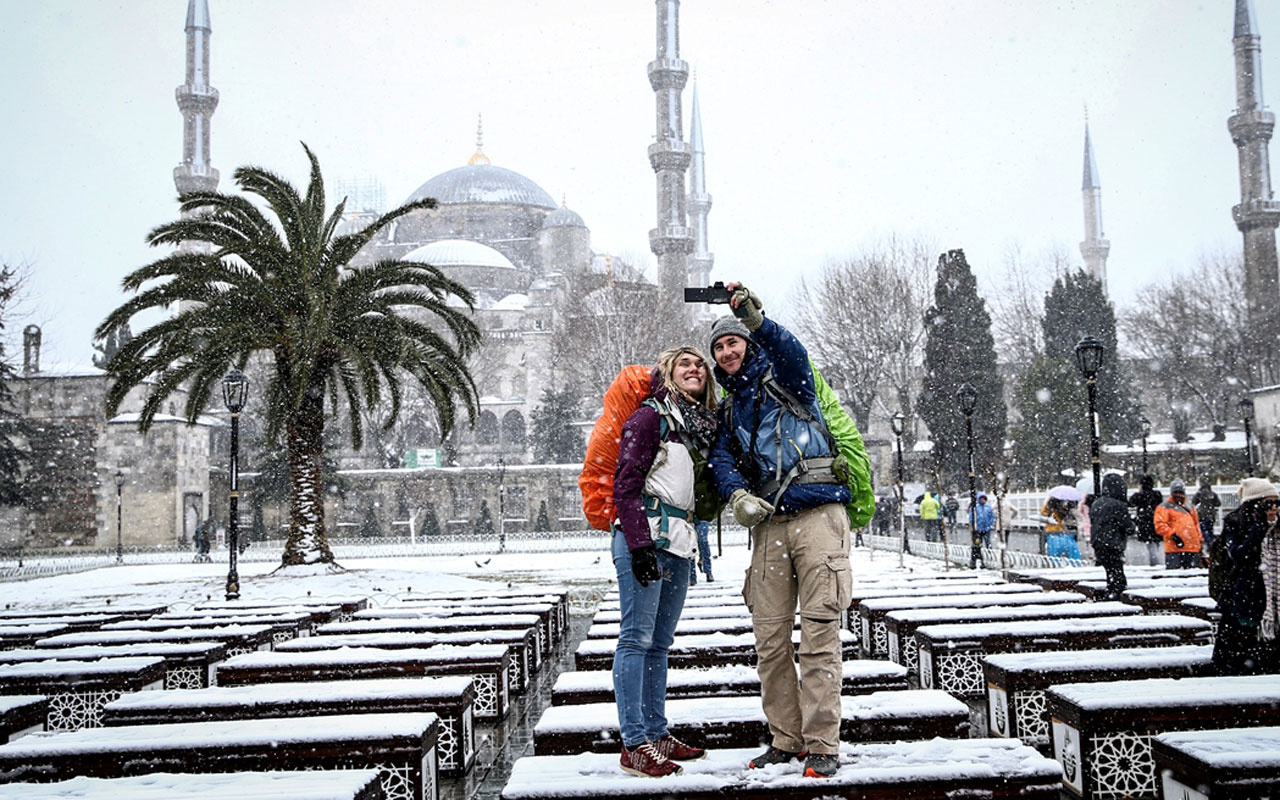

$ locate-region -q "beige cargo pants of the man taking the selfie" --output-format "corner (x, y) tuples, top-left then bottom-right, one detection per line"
(742, 503), (852, 754)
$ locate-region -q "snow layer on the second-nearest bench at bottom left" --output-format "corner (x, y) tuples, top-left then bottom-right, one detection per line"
(0, 712), (439, 760)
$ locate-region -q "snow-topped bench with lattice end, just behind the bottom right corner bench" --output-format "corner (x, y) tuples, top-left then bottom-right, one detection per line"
(1044, 675), (1280, 799)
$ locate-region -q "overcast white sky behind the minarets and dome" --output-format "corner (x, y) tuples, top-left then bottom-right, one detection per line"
(0, 0), (1264, 364)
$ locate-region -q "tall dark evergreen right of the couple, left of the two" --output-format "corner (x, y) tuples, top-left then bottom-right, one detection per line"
(919, 250), (1007, 486)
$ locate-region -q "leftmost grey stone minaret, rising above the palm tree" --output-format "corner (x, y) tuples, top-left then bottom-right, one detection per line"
(173, 0), (218, 195)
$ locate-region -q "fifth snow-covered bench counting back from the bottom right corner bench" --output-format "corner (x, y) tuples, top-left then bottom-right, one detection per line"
(884, 591), (1142, 675)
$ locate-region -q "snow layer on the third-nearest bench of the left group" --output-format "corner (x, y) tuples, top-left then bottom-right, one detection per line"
(108, 676), (472, 710)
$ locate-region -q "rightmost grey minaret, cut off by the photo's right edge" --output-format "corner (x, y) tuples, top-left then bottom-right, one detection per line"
(1226, 0), (1280, 383)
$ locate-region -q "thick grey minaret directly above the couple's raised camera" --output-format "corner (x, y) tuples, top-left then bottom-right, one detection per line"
(649, 0), (694, 303)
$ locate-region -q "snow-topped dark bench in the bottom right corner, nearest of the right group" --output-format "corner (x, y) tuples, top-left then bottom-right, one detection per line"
(1151, 727), (1280, 800)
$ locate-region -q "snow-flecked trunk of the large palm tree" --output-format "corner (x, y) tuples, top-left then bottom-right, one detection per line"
(283, 393), (333, 567)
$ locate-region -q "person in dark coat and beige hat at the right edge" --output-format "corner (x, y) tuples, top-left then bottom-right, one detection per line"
(1211, 477), (1280, 675)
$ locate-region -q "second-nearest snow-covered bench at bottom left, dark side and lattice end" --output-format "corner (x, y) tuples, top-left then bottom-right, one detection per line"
(0, 713), (440, 800)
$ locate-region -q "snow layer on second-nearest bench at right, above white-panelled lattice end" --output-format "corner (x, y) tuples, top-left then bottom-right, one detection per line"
(1050, 675), (1280, 710)
